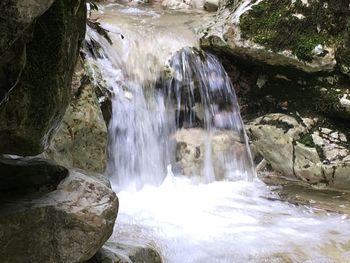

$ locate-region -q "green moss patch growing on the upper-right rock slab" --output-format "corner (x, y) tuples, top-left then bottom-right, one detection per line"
(240, 0), (348, 62)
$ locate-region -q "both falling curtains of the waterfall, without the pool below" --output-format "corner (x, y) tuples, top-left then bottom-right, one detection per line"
(88, 22), (254, 190)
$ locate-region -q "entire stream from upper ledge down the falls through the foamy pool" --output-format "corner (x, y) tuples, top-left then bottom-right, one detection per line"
(87, 4), (350, 263)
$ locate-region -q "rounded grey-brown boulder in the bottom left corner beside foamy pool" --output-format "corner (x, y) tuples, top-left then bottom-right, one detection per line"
(0, 171), (118, 263)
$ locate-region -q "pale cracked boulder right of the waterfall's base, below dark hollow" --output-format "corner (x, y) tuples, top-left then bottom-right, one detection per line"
(247, 114), (350, 189)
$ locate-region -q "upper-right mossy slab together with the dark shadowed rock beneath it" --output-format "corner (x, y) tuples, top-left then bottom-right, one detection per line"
(201, 0), (350, 120)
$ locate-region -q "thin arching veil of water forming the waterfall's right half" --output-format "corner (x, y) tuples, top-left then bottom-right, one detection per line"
(166, 48), (255, 182)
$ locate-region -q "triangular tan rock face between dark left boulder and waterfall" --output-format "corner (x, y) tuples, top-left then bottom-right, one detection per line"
(46, 58), (107, 173)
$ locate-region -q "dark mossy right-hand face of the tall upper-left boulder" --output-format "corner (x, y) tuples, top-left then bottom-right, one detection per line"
(0, 0), (86, 155)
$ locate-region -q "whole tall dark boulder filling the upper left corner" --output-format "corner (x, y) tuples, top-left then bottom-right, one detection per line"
(0, 0), (86, 155)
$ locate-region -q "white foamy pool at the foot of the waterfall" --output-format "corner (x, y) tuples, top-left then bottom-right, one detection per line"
(112, 175), (350, 263)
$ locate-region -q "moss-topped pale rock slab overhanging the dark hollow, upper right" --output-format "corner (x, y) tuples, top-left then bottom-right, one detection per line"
(200, 0), (350, 74)
